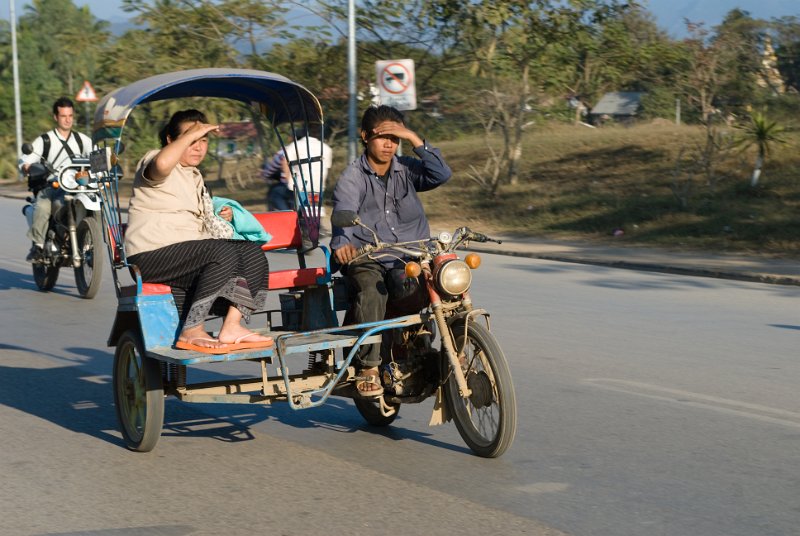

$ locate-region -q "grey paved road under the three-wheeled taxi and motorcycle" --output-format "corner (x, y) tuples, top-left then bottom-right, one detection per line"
(0, 194), (800, 536)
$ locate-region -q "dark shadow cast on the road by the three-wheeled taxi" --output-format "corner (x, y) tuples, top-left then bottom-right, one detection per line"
(0, 343), (469, 452)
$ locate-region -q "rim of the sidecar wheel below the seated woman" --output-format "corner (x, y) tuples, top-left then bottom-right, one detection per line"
(117, 342), (147, 442)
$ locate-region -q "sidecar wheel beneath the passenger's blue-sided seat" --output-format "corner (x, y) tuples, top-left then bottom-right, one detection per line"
(114, 330), (164, 452)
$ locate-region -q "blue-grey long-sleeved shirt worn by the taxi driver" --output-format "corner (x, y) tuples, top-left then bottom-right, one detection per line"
(331, 143), (452, 265)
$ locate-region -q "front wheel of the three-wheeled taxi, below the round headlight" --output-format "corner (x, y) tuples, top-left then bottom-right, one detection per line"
(445, 320), (517, 458)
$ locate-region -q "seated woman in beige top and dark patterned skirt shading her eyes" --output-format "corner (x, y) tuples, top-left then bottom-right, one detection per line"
(125, 110), (273, 353)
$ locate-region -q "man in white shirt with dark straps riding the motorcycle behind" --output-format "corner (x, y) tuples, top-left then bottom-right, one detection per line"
(19, 97), (92, 262)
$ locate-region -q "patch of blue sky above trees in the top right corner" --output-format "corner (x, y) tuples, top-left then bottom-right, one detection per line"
(643, 0), (800, 37)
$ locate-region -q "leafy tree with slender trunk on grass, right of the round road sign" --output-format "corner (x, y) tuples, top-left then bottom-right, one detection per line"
(434, 0), (627, 195)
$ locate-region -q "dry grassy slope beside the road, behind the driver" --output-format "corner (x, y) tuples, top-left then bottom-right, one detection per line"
(219, 124), (800, 257)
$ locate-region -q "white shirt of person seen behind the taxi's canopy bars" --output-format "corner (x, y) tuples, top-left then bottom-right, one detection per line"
(284, 132), (333, 216)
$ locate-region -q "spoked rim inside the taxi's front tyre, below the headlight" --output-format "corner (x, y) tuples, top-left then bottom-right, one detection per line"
(451, 337), (502, 445)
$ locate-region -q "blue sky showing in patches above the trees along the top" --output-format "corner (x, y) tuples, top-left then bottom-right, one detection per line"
(0, 0), (800, 37)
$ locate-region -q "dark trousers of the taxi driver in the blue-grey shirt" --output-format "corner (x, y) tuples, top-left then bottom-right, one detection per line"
(344, 259), (389, 368)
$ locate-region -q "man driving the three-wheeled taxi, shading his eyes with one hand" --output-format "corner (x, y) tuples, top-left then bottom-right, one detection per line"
(331, 105), (451, 398)
